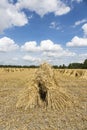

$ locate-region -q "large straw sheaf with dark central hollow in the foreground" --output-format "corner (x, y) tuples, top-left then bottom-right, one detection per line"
(16, 63), (72, 110)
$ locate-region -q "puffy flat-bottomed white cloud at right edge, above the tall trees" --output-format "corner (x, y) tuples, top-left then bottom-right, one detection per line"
(66, 36), (87, 47)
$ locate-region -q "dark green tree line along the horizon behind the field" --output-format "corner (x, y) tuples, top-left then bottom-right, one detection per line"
(0, 59), (87, 69)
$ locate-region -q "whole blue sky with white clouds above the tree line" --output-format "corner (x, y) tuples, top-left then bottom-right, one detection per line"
(0, 0), (87, 65)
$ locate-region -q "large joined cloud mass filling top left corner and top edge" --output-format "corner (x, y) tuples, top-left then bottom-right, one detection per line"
(0, 0), (70, 33)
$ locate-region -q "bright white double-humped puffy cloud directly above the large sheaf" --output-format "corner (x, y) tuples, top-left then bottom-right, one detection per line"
(21, 40), (62, 52)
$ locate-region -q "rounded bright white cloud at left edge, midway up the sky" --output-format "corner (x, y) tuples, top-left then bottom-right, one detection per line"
(0, 37), (19, 52)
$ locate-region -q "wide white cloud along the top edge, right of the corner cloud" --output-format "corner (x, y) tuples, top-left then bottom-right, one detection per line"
(16, 0), (70, 16)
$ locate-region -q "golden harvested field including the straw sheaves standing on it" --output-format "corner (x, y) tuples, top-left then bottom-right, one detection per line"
(0, 66), (87, 130)
